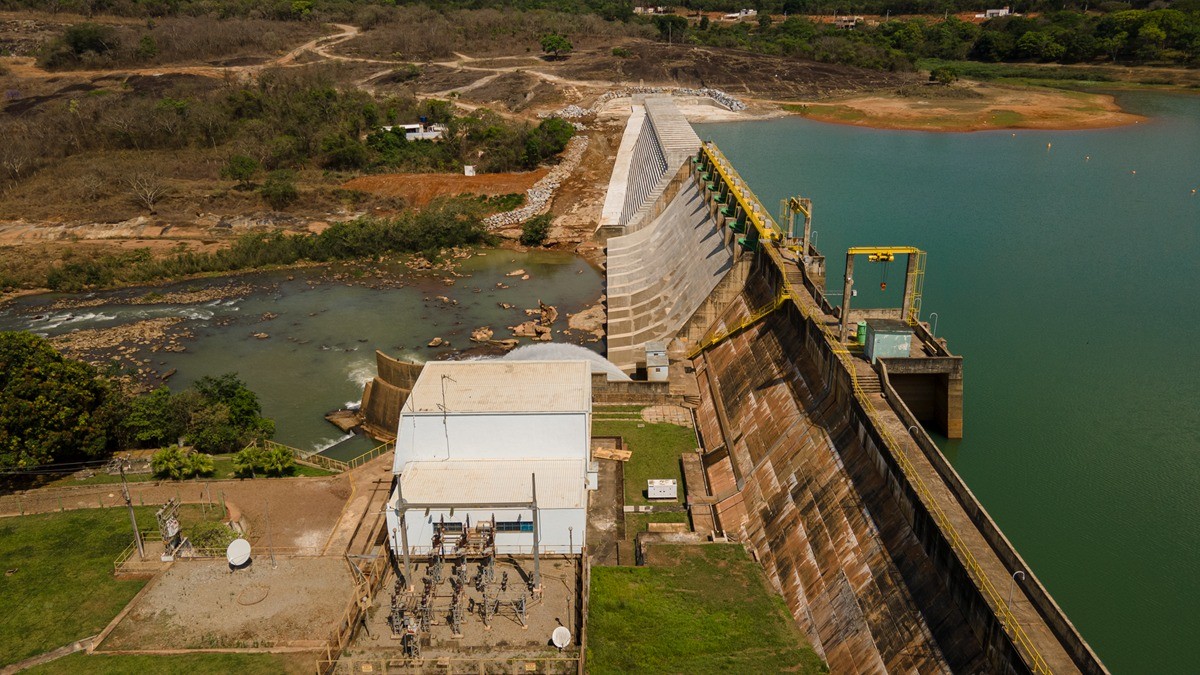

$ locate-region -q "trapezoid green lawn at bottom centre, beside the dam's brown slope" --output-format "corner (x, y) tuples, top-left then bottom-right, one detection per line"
(588, 544), (827, 675)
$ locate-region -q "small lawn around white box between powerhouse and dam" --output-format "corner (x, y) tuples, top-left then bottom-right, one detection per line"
(592, 419), (696, 504)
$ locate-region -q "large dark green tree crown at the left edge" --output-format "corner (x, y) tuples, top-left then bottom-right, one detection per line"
(0, 331), (125, 468)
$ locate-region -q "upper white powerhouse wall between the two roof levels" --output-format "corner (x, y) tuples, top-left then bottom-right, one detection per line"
(394, 412), (592, 473)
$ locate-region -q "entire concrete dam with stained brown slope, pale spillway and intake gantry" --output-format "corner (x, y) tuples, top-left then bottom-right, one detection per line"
(598, 96), (1108, 675)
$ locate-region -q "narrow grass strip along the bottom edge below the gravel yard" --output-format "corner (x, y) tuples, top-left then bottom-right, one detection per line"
(25, 653), (317, 675)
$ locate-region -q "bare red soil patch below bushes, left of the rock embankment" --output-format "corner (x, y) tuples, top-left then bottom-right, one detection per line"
(343, 168), (548, 207)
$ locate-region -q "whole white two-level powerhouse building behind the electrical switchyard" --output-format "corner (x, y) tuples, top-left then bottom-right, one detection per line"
(388, 360), (592, 556)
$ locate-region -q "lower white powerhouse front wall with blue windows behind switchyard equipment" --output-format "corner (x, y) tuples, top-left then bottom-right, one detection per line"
(388, 508), (587, 556)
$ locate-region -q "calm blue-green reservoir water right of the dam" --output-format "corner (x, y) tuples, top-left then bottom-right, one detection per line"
(697, 94), (1200, 673)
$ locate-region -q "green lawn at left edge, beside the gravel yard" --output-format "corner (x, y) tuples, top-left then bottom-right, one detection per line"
(0, 506), (221, 665)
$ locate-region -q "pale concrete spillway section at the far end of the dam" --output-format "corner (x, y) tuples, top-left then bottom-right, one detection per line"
(601, 98), (733, 372)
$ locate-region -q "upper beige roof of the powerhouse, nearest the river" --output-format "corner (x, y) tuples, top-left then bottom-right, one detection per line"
(403, 360), (592, 414)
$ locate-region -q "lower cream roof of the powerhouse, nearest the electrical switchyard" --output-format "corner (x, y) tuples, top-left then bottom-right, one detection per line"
(400, 460), (587, 508)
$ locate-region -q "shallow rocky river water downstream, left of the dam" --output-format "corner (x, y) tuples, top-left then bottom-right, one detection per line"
(0, 250), (602, 459)
